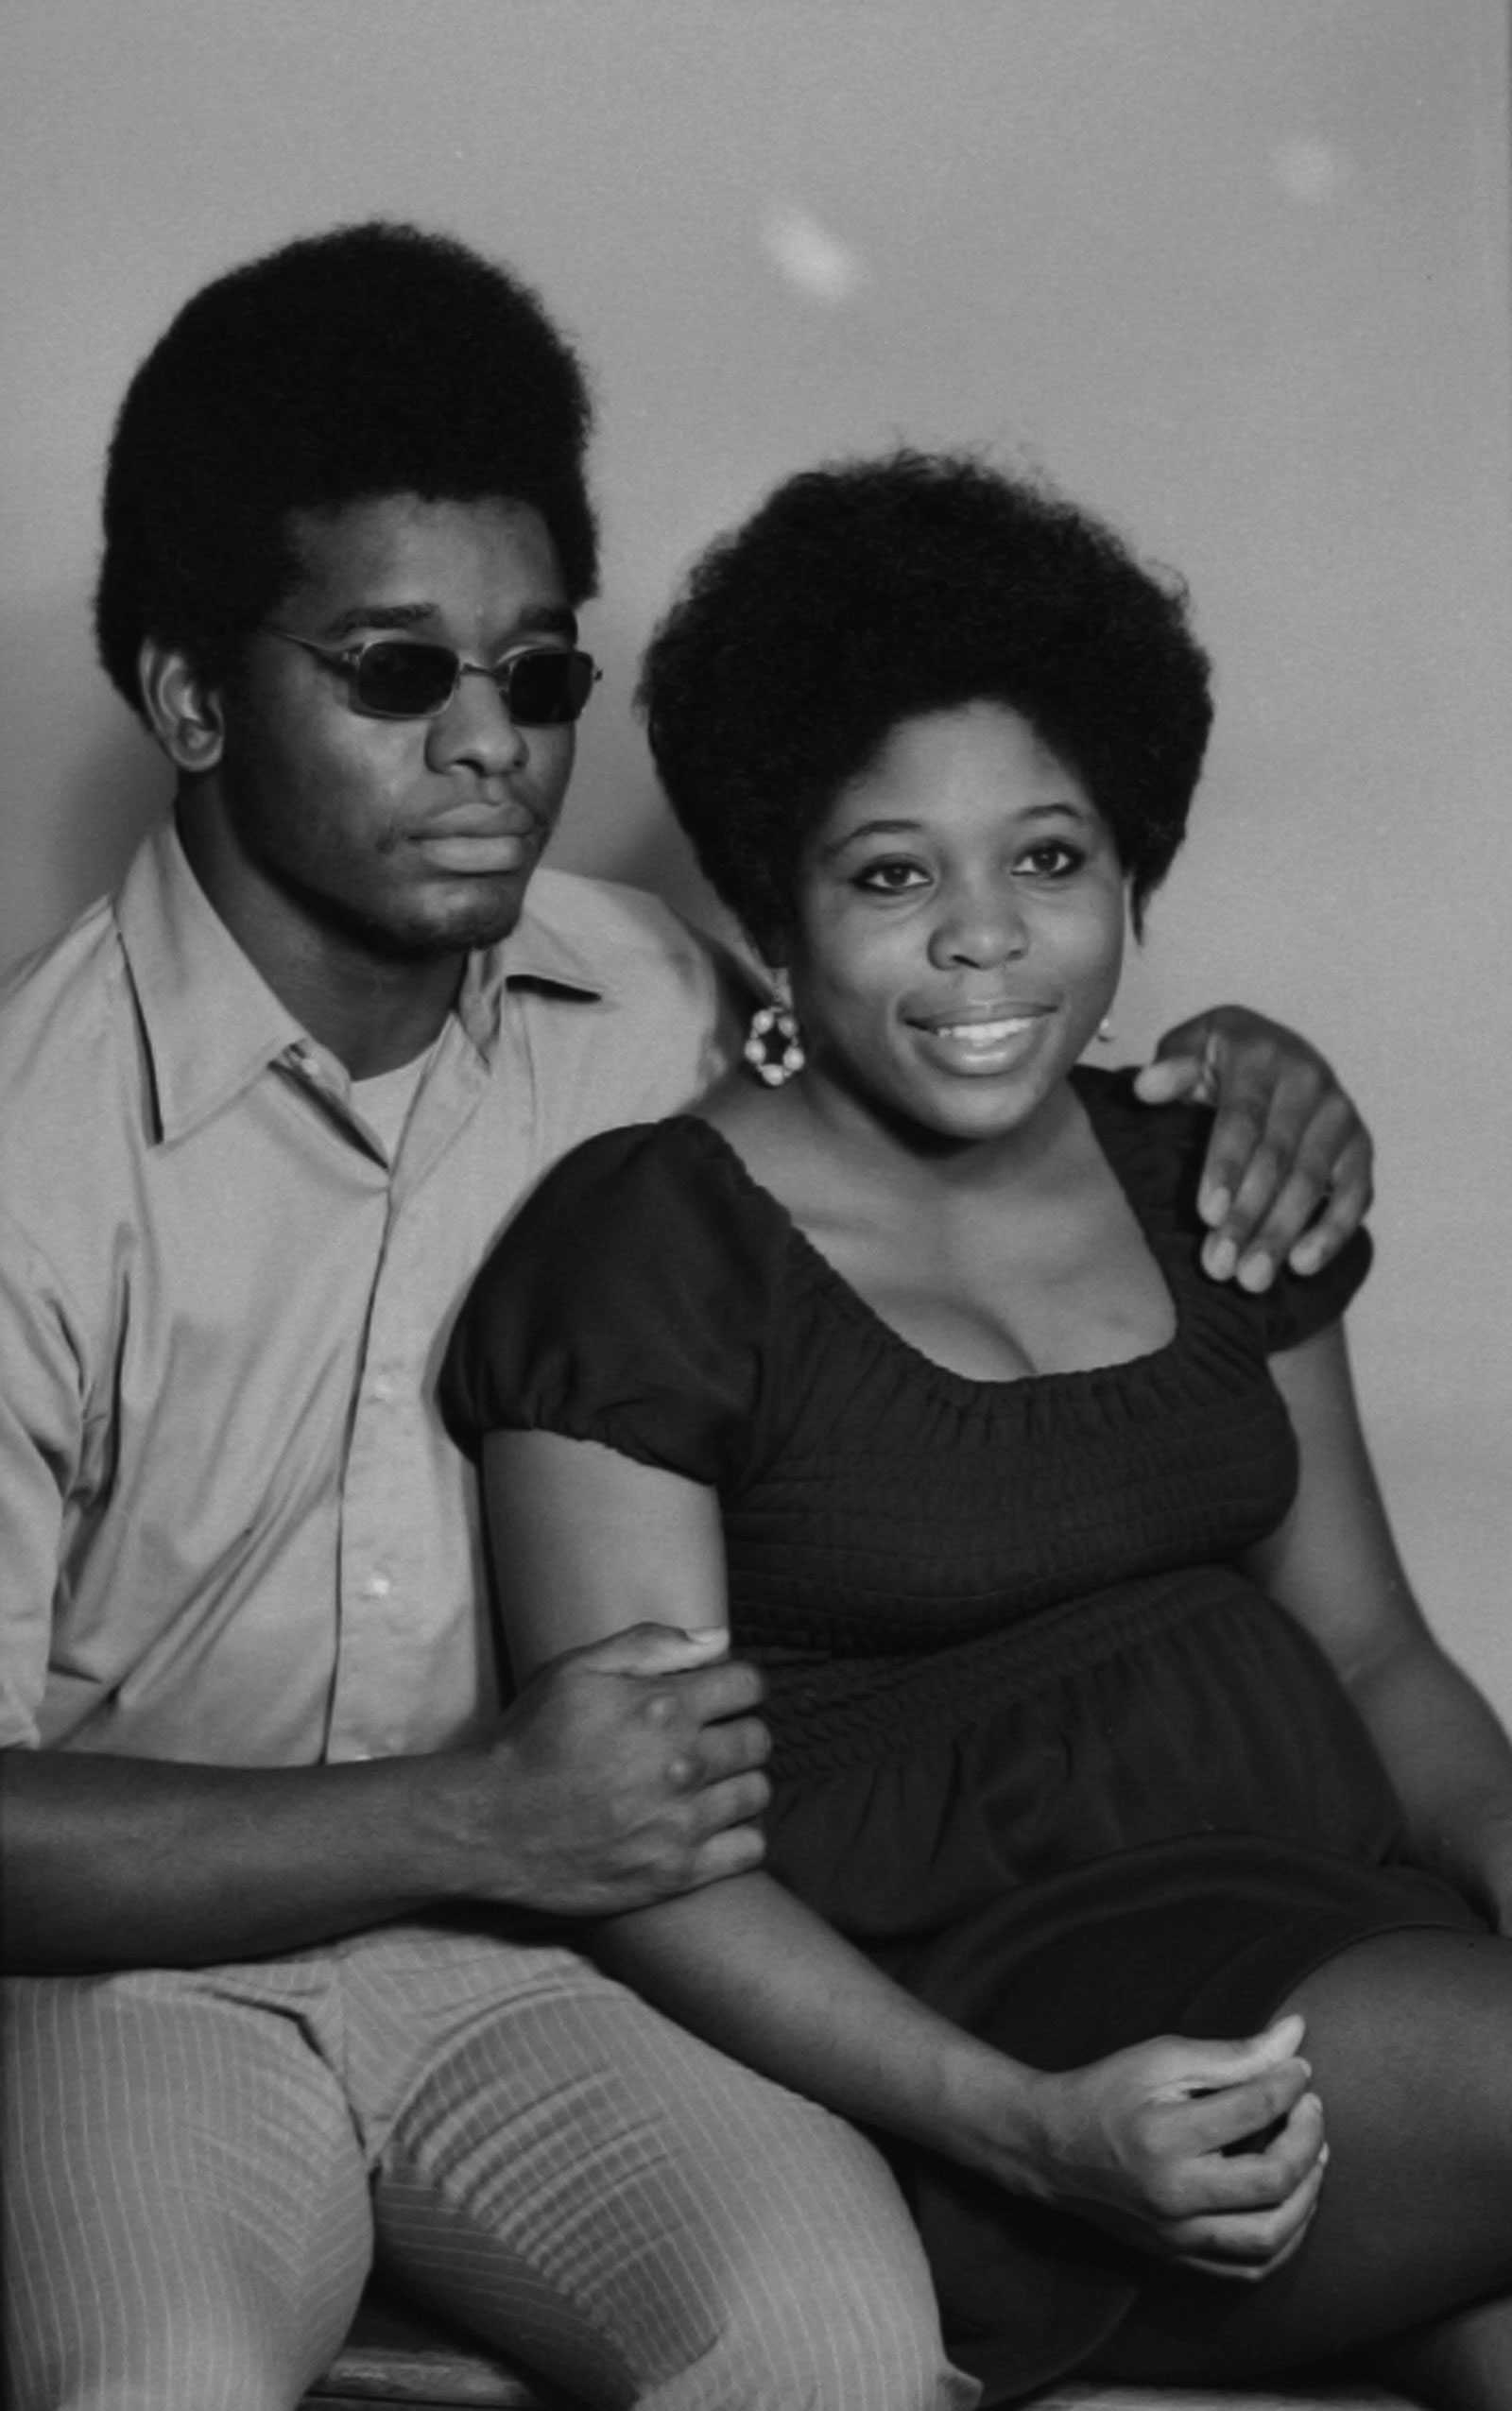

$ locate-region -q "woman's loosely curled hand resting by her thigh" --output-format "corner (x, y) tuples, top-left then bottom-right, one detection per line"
(1018, 2016), (1327, 2283)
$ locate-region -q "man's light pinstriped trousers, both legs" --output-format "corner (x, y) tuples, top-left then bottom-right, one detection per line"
(3, 1924), (976, 2411)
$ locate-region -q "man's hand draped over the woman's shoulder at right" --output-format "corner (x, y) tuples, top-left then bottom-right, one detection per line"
(1136, 1006), (1375, 1290)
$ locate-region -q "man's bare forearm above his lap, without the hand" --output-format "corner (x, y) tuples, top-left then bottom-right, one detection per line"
(0, 1750), (491, 1974)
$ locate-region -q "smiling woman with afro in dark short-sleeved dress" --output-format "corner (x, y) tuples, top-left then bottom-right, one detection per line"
(446, 454), (1512, 2411)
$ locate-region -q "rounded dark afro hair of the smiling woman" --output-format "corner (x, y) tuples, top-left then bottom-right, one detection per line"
(637, 451), (1211, 959)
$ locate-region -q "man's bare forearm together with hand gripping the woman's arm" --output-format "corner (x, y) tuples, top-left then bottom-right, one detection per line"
(0, 1627), (766, 1972)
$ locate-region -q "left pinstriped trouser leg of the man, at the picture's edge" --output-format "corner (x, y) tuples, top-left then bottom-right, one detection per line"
(3, 1963), (371, 2411)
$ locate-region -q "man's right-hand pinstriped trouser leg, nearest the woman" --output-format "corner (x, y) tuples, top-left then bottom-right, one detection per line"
(345, 1931), (976, 2411)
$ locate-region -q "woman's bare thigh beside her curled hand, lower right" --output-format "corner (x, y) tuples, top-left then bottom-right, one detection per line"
(1092, 1931), (1512, 2385)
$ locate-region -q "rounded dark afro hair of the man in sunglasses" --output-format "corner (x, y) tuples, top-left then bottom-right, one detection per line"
(94, 219), (598, 712)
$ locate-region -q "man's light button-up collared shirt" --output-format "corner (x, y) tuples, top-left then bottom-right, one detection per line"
(0, 827), (730, 1765)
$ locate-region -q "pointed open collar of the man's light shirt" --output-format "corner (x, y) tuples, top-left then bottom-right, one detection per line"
(115, 819), (608, 1141)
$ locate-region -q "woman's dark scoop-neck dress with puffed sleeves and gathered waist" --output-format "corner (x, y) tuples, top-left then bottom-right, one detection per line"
(444, 1071), (1478, 2402)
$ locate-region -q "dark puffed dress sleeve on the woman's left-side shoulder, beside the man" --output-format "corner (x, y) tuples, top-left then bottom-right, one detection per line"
(441, 1116), (782, 1485)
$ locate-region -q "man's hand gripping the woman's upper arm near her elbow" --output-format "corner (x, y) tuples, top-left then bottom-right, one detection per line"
(471, 1625), (769, 1917)
